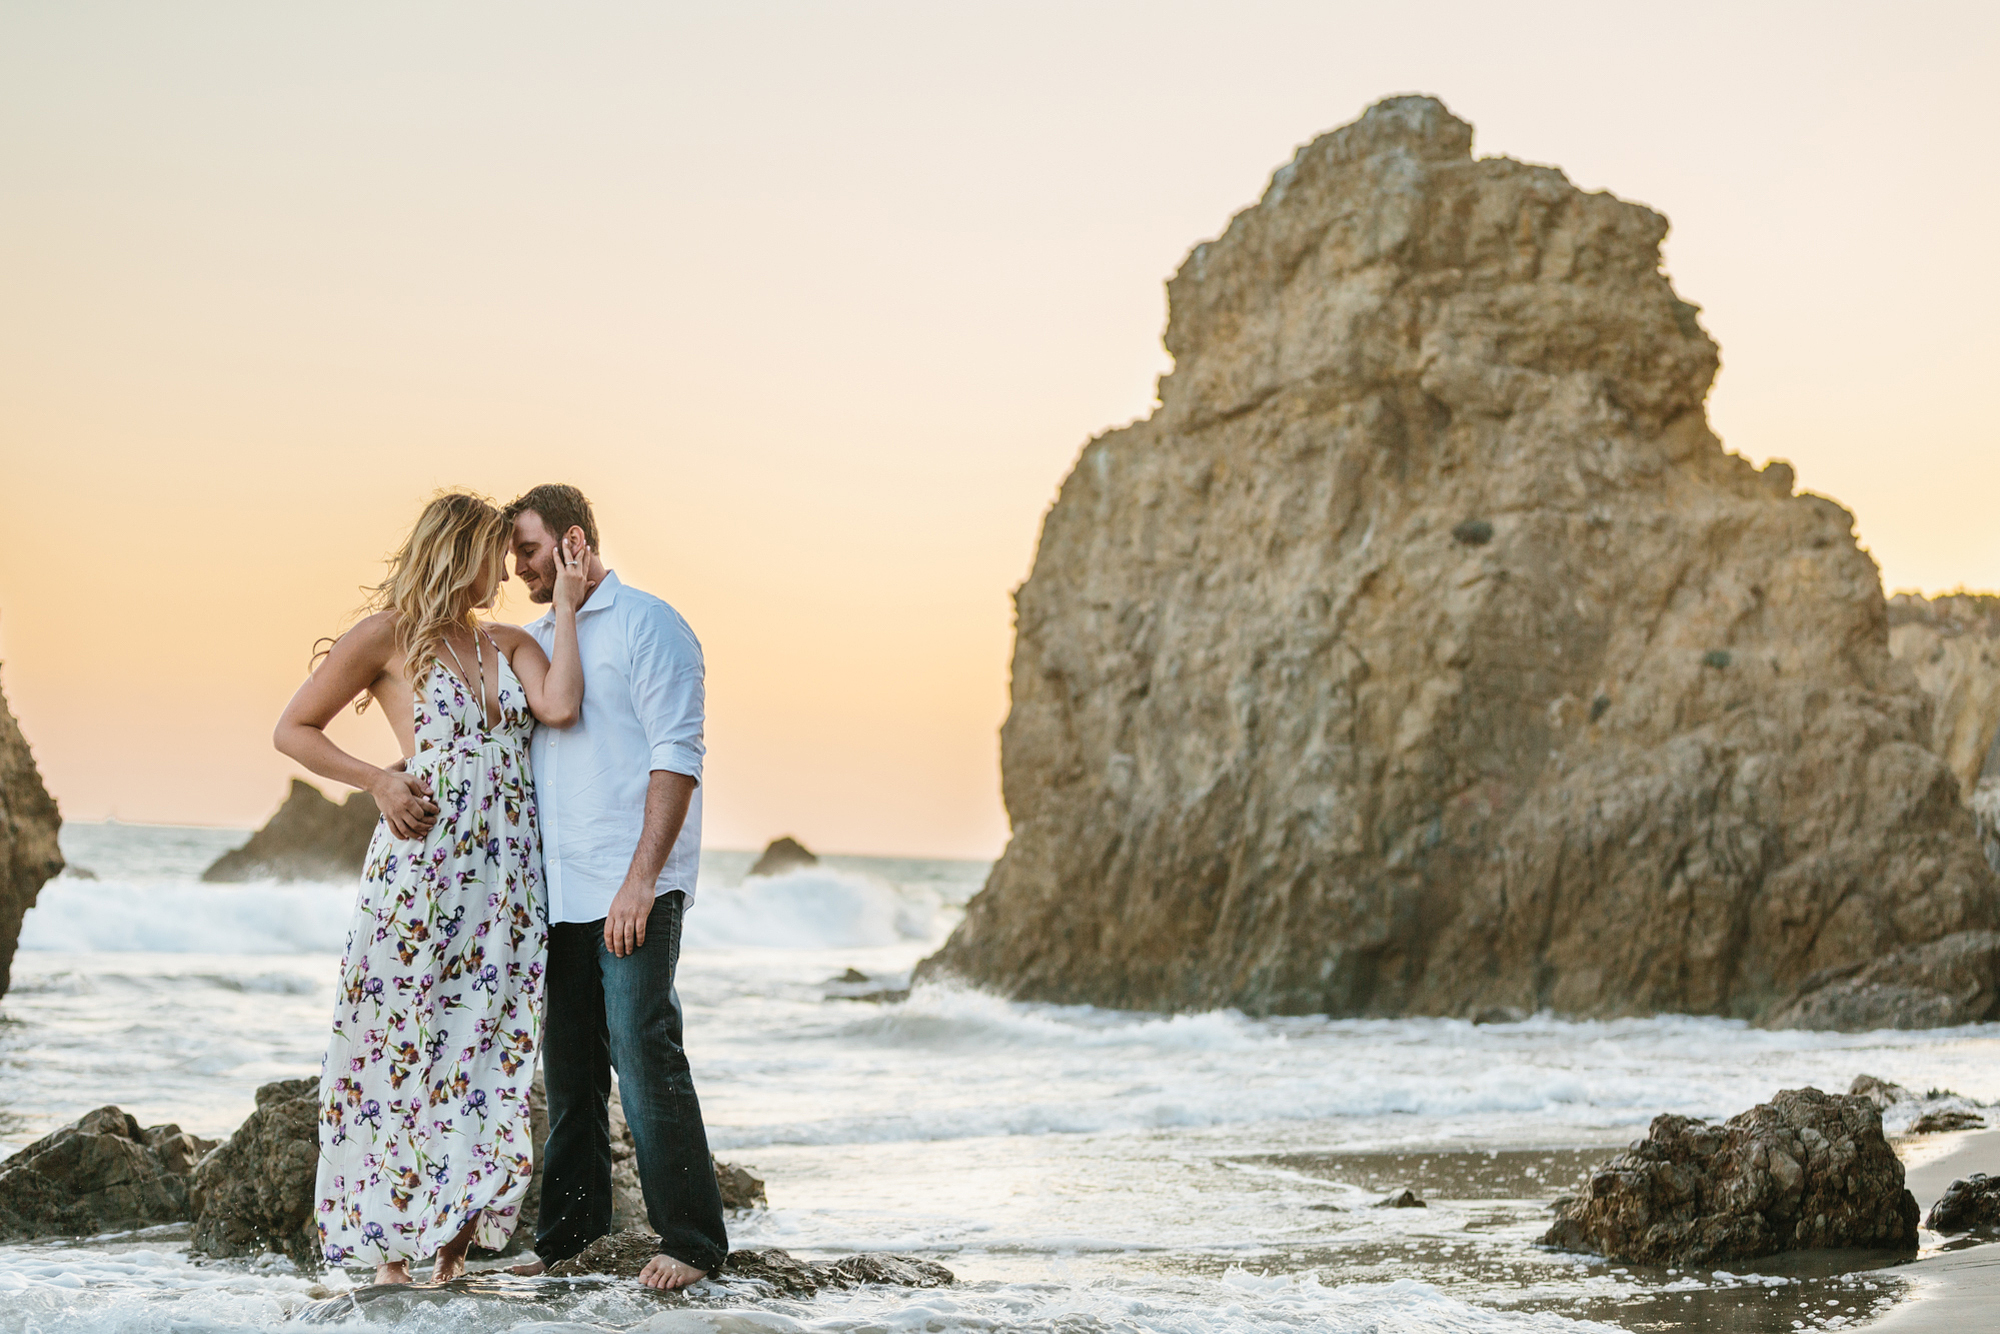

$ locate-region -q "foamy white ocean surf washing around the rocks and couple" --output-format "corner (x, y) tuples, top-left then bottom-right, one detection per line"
(0, 824), (2000, 1334)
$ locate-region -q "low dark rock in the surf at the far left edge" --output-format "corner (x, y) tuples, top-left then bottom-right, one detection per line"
(0, 1106), (214, 1242)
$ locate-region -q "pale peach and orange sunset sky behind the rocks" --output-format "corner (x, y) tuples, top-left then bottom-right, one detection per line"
(0, 0), (2000, 856)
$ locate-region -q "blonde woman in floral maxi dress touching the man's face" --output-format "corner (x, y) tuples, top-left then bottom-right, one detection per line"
(276, 494), (588, 1284)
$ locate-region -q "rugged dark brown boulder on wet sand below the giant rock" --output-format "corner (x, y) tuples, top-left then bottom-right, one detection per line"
(1542, 1088), (1916, 1264)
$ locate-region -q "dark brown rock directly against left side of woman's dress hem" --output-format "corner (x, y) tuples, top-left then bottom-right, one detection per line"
(188, 1078), (320, 1270)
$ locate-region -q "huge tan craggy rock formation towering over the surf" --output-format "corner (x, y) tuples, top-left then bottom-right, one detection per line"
(924, 98), (2000, 1016)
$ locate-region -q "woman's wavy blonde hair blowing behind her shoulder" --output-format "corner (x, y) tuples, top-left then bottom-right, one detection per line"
(314, 492), (508, 712)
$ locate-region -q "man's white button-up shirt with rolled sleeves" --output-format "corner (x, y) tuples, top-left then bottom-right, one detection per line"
(528, 570), (706, 922)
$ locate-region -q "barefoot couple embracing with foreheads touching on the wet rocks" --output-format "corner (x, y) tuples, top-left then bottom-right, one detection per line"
(276, 486), (728, 1288)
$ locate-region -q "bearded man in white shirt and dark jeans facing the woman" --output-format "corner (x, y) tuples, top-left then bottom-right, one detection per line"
(506, 486), (728, 1288)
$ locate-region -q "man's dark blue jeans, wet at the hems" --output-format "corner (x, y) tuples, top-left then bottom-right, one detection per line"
(534, 890), (730, 1274)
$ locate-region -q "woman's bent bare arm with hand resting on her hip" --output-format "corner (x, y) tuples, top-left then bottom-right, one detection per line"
(270, 612), (438, 838)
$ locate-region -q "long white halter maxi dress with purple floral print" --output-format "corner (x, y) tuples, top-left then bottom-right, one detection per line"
(314, 646), (548, 1264)
